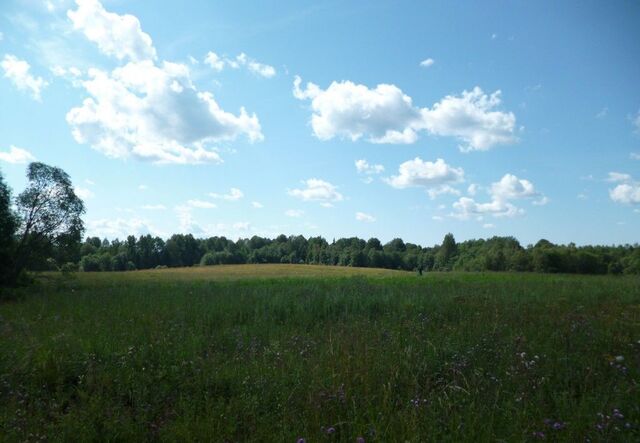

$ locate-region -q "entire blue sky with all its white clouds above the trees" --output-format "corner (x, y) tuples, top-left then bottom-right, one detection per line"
(0, 0), (640, 245)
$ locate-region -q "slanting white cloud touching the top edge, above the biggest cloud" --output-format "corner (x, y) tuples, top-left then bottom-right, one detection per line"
(67, 0), (157, 61)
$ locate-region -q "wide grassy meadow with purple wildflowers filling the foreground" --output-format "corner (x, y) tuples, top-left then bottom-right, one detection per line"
(0, 265), (640, 442)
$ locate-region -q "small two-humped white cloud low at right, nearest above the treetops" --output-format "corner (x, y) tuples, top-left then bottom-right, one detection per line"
(451, 174), (548, 220)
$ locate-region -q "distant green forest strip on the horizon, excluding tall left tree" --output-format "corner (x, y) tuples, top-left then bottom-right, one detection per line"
(62, 234), (640, 274)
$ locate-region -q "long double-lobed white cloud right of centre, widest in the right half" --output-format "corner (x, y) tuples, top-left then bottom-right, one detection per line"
(293, 76), (517, 151)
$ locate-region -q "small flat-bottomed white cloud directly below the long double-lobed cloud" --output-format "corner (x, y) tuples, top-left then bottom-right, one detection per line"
(385, 157), (464, 191)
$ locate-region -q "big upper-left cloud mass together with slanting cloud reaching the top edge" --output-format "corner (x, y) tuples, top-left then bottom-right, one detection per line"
(64, 0), (264, 164)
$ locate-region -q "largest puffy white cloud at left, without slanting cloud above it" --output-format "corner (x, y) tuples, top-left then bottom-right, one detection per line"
(67, 61), (263, 164)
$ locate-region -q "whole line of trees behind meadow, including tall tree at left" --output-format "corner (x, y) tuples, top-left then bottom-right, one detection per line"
(0, 162), (640, 286)
